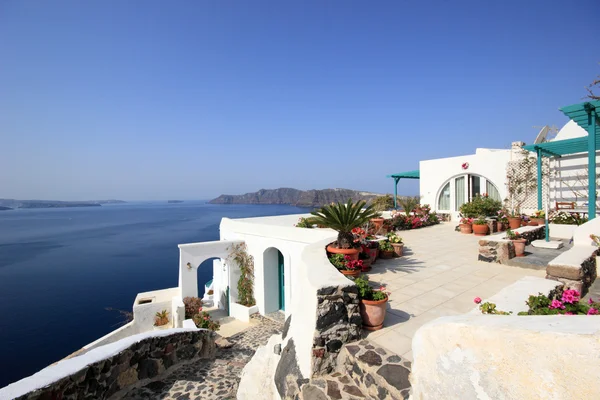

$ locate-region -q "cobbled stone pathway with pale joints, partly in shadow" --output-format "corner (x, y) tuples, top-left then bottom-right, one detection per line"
(123, 314), (283, 400)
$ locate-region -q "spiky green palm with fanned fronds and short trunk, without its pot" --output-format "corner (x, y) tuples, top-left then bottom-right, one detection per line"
(311, 199), (378, 249)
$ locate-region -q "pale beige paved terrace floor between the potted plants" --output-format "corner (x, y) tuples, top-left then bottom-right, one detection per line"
(364, 222), (546, 361)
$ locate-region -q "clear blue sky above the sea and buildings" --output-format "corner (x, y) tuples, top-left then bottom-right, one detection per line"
(0, 0), (600, 200)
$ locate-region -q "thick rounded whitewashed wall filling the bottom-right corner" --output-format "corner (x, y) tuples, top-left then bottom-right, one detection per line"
(410, 315), (600, 400)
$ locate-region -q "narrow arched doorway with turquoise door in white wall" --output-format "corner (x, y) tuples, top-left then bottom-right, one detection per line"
(263, 247), (285, 313)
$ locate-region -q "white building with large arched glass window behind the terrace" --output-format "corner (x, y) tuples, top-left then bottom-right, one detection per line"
(390, 121), (598, 220)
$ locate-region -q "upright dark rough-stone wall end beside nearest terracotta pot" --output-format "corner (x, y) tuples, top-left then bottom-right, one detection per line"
(312, 285), (362, 376)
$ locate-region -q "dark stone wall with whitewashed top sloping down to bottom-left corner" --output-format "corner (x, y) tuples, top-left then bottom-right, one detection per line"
(7, 330), (216, 400)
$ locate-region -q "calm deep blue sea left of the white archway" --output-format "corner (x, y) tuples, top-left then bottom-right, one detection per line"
(0, 201), (307, 387)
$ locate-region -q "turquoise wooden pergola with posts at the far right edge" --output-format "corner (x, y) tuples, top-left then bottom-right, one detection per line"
(523, 100), (600, 219)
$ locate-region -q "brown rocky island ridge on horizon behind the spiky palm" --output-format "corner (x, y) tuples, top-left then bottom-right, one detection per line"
(209, 188), (380, 207)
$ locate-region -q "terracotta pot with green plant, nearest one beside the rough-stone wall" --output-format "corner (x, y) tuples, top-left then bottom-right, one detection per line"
(354, 276), (389, 331)
